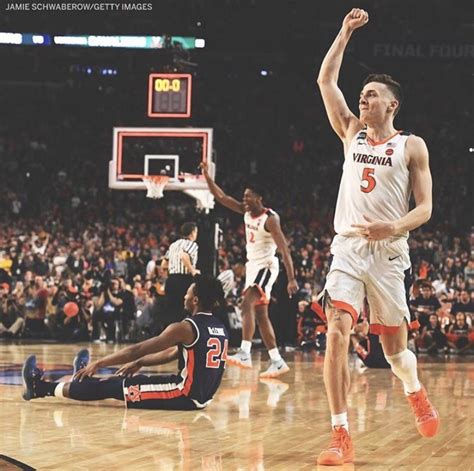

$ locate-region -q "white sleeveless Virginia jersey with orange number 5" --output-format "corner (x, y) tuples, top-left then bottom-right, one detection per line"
(334, 130), (411, 237)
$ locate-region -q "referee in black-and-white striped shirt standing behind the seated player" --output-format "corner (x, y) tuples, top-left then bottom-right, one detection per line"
(161, 222), (201, 323)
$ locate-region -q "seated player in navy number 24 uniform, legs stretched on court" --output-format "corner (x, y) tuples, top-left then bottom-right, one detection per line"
(23, 276), (228, 410)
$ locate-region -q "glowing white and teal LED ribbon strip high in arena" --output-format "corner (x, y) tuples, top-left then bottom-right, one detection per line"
(0, 32), (206, 49)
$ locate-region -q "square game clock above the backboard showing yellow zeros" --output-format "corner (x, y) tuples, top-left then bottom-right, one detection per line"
(148, 74), (192, 118)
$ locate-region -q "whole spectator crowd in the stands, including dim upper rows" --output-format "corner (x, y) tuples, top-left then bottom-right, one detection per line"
(0, 42), (474, 352)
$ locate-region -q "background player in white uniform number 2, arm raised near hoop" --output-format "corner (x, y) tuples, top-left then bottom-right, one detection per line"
(201, 163), (298, 378)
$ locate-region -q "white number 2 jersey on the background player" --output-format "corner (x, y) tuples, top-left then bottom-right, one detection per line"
(244, 209), (277, 263)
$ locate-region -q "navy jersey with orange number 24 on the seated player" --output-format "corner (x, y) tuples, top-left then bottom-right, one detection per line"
(178, 313), (229, 405)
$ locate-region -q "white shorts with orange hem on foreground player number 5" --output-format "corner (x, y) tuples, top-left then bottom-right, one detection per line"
(324, 235), (411, 334)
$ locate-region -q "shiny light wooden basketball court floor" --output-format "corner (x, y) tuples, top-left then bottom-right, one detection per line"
(0, 344), (474, 471)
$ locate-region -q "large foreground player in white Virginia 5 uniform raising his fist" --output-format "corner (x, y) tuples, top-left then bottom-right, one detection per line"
(318, 8), (439, 465)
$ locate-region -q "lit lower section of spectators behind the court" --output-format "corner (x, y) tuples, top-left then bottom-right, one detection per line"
(0, 142), (474, 352)
